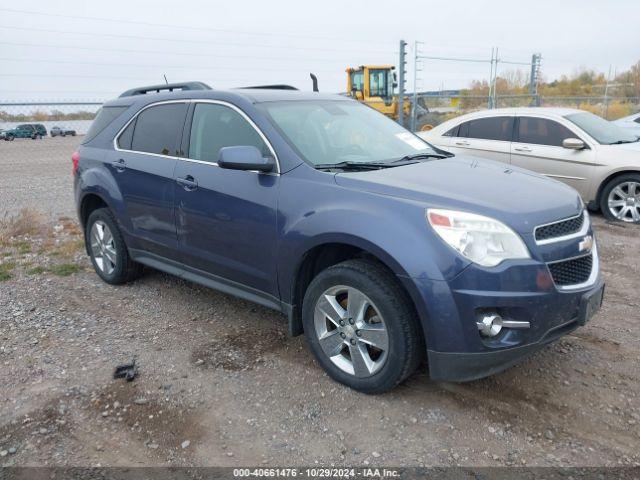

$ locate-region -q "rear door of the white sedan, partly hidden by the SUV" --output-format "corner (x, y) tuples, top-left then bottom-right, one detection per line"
(445, 115), (514, 163)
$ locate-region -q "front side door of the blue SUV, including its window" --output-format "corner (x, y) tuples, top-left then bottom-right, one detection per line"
(174, 102), (279, 297)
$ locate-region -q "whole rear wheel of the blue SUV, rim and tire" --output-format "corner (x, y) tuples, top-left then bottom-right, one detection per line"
(85, 208), (142, 285)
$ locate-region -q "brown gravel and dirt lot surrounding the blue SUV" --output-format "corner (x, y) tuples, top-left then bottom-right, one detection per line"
(0, 135), (640, 466)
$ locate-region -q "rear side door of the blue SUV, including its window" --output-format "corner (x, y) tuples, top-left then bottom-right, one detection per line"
(106, 101), (188, 258)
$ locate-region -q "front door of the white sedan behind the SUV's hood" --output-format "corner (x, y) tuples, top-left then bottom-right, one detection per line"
(511, 115), (595, 196)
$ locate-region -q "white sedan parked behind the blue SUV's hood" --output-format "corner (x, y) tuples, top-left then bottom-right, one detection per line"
(418, 108), (640, 223)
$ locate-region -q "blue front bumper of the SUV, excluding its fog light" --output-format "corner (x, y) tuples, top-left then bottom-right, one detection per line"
(405, 261), (604, 381)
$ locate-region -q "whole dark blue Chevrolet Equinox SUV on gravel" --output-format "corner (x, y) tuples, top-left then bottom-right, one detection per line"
(72, 82), (604, 393)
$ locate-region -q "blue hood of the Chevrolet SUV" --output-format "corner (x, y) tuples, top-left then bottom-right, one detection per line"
(335, 156), (583, 233)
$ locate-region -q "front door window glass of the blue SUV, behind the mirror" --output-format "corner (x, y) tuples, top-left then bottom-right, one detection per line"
(190, 103), (271, 163)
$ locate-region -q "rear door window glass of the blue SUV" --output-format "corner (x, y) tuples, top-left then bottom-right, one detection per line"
(131, 103), (187, 155)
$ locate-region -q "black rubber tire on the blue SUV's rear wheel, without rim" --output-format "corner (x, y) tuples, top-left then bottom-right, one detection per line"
(84, 208), (142, 285)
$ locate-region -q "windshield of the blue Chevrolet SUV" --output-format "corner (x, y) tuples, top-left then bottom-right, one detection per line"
(259, 100), (436, 165)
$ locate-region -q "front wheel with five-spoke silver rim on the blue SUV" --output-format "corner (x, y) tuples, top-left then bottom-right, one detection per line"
(302, 259), (423, 393)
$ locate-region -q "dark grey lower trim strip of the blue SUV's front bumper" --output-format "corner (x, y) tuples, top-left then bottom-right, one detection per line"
(427, 280), (604, 382)
